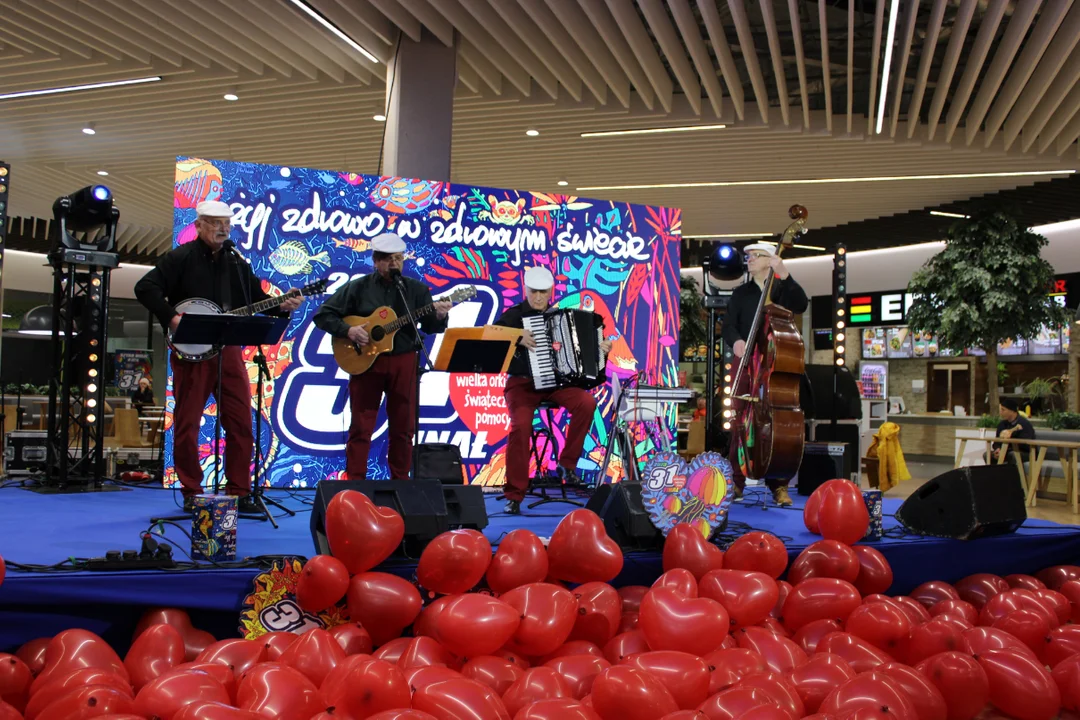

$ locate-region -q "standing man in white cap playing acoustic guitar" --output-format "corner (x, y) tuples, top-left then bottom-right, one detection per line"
(313, 232), (454, 480)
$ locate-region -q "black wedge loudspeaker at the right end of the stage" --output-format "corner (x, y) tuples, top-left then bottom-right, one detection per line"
(896, 465), (1027, 540)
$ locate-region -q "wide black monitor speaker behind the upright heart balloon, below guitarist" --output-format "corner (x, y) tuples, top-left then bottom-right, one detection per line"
(311, 480), (464, 558)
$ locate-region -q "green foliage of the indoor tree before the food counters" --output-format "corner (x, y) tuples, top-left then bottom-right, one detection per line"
(907, 207), (1069, 353)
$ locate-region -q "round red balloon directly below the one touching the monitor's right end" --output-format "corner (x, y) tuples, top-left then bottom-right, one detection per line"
(434, 594), (522, 657)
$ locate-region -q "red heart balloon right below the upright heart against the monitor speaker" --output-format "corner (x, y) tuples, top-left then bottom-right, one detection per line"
(349, 574), (423, 647)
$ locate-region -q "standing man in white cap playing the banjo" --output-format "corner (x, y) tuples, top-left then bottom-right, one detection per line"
(135, 200), (302, 513)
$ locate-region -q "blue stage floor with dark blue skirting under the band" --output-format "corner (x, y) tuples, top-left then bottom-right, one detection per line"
(0, 484), (1080, 652)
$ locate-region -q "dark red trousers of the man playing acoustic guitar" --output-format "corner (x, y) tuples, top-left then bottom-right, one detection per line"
(346, 352), (416, 480)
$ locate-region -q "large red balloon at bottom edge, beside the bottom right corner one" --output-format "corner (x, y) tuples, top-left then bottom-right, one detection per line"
(976, 650), (1062, 720)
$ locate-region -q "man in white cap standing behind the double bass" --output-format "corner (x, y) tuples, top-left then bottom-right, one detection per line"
(720, 243), (809, 505)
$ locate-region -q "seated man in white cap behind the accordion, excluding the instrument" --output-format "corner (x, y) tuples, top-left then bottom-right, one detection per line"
(495, 267), (611, 515)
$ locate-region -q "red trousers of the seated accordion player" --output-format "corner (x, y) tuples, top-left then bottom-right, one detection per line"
(502, 377), (596, 502)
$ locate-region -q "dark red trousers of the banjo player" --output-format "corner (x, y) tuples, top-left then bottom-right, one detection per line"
(172, 348), (255, 498)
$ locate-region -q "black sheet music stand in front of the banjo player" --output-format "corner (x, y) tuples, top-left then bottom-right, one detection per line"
(151, 313), (288, 522)
